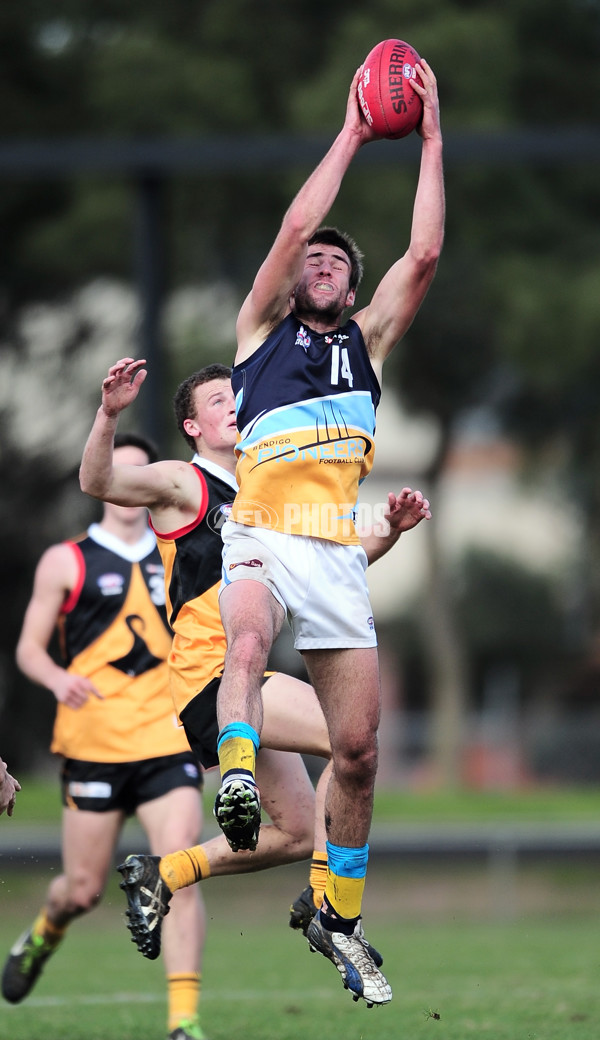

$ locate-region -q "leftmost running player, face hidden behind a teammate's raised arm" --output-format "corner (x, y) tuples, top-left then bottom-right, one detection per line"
(2, 434), (205, 1040)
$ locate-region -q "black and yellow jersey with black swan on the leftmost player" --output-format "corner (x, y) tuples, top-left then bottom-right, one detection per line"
(51, 524), (189, 762)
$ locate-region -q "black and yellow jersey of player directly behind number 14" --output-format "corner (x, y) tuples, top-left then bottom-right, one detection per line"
(148, 456), (237, 714)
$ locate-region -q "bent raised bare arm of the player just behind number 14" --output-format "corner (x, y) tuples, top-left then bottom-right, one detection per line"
(79, 358), (196, 530)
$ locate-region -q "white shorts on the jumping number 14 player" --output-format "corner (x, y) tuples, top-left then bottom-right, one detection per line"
(220, 520), (377, 650)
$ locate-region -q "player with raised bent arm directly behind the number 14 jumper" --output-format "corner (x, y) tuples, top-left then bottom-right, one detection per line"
(80, 358), (431, 973)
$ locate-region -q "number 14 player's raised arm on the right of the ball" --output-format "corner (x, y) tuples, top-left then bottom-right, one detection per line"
(354, 59), (445, 374)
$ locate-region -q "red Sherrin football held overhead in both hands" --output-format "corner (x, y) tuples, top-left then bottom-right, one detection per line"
(358, 40), (423, 137)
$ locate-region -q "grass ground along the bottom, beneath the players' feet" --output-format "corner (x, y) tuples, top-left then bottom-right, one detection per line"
(0, 860), (600, 1040)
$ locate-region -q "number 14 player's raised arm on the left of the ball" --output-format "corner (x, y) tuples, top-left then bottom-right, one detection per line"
(236, 69), (376, 362)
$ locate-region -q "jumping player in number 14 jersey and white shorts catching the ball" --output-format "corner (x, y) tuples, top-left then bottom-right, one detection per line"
(214, 60), (445, 1005)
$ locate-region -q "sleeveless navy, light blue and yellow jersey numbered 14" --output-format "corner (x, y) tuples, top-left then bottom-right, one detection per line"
(232, 314), (381, 545)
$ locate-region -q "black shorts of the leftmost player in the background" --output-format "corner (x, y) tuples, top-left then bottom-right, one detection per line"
(60, 751), (202, 816)
